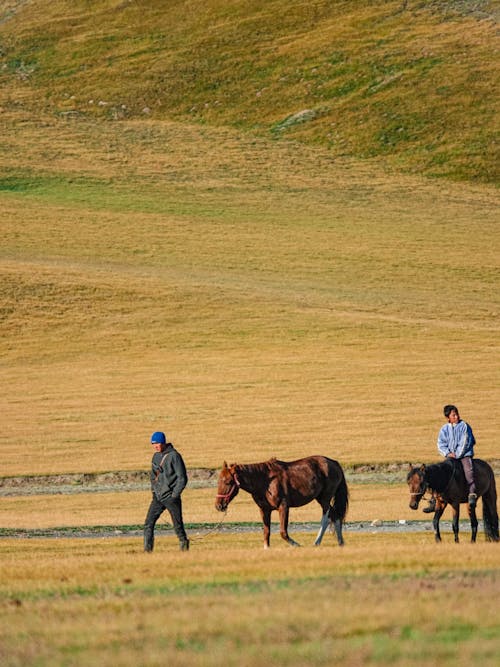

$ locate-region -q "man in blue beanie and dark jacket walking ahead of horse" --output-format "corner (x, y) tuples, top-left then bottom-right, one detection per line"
(144, 431), (189, 551)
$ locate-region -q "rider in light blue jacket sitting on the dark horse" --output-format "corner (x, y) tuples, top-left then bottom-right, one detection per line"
(423, 405), (477, 512)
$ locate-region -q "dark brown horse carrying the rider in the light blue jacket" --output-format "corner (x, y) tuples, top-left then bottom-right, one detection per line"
(407, 459), (499, 542)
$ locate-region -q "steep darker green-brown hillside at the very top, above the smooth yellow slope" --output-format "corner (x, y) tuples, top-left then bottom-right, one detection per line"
(0, 0), (499, 181)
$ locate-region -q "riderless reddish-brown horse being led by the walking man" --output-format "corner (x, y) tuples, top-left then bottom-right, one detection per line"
(215, 456), (349, 549)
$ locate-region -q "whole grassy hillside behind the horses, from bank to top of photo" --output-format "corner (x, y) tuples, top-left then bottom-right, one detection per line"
(0, 0), (500, 480)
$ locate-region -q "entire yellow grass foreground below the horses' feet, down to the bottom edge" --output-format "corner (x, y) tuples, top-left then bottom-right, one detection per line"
(0, 535), (500, 667)
